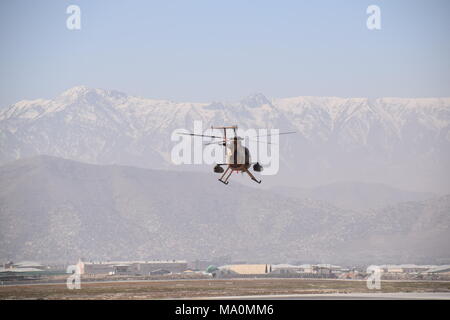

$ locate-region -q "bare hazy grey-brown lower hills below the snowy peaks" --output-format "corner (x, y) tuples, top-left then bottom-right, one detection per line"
(0, 156), (450, 265)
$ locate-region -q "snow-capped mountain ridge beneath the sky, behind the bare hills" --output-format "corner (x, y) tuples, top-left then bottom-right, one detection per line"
(0, 86), (450, 192)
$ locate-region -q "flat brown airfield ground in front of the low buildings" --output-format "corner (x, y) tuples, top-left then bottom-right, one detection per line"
(0, 278), (450, 300)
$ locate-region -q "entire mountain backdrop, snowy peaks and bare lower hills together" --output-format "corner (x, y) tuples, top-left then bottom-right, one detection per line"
(0, 86), (450, 264)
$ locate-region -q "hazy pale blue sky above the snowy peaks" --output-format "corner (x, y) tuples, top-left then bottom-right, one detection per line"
(0, 0), (450, 106)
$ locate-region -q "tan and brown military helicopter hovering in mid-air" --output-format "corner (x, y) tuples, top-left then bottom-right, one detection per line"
(178, 125), (295, 185)
